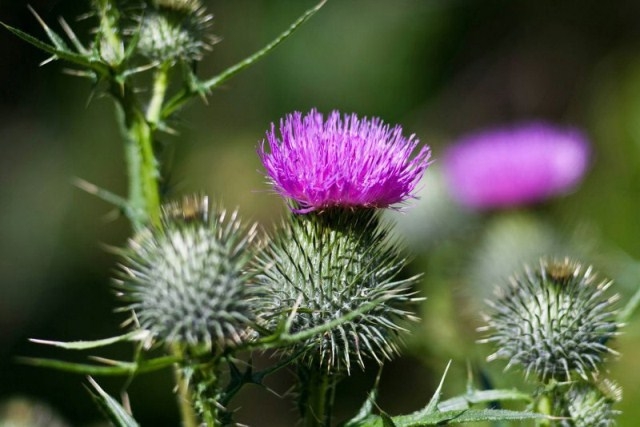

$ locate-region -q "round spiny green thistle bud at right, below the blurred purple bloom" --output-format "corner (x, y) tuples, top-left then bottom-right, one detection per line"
(480, 259), (621, 382)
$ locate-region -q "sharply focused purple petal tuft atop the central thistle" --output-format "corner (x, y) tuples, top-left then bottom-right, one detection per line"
(258, 109), (431, 213)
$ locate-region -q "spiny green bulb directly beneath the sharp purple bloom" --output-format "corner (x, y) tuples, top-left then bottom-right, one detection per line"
(258, 209), (416, 372)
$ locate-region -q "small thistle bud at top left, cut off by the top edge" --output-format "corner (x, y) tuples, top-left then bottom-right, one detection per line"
(137, 0), (215, 63)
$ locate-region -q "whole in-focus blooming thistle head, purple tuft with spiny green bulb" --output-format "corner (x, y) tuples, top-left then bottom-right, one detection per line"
(258, 110), (430, 425)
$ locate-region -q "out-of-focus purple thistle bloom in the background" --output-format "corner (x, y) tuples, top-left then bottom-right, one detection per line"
(444, 122), (589, 209)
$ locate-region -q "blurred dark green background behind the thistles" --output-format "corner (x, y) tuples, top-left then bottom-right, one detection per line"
(0, 0), (640, 426)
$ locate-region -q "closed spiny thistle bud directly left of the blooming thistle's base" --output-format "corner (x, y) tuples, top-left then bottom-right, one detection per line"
(117, 197), (256, 348)
